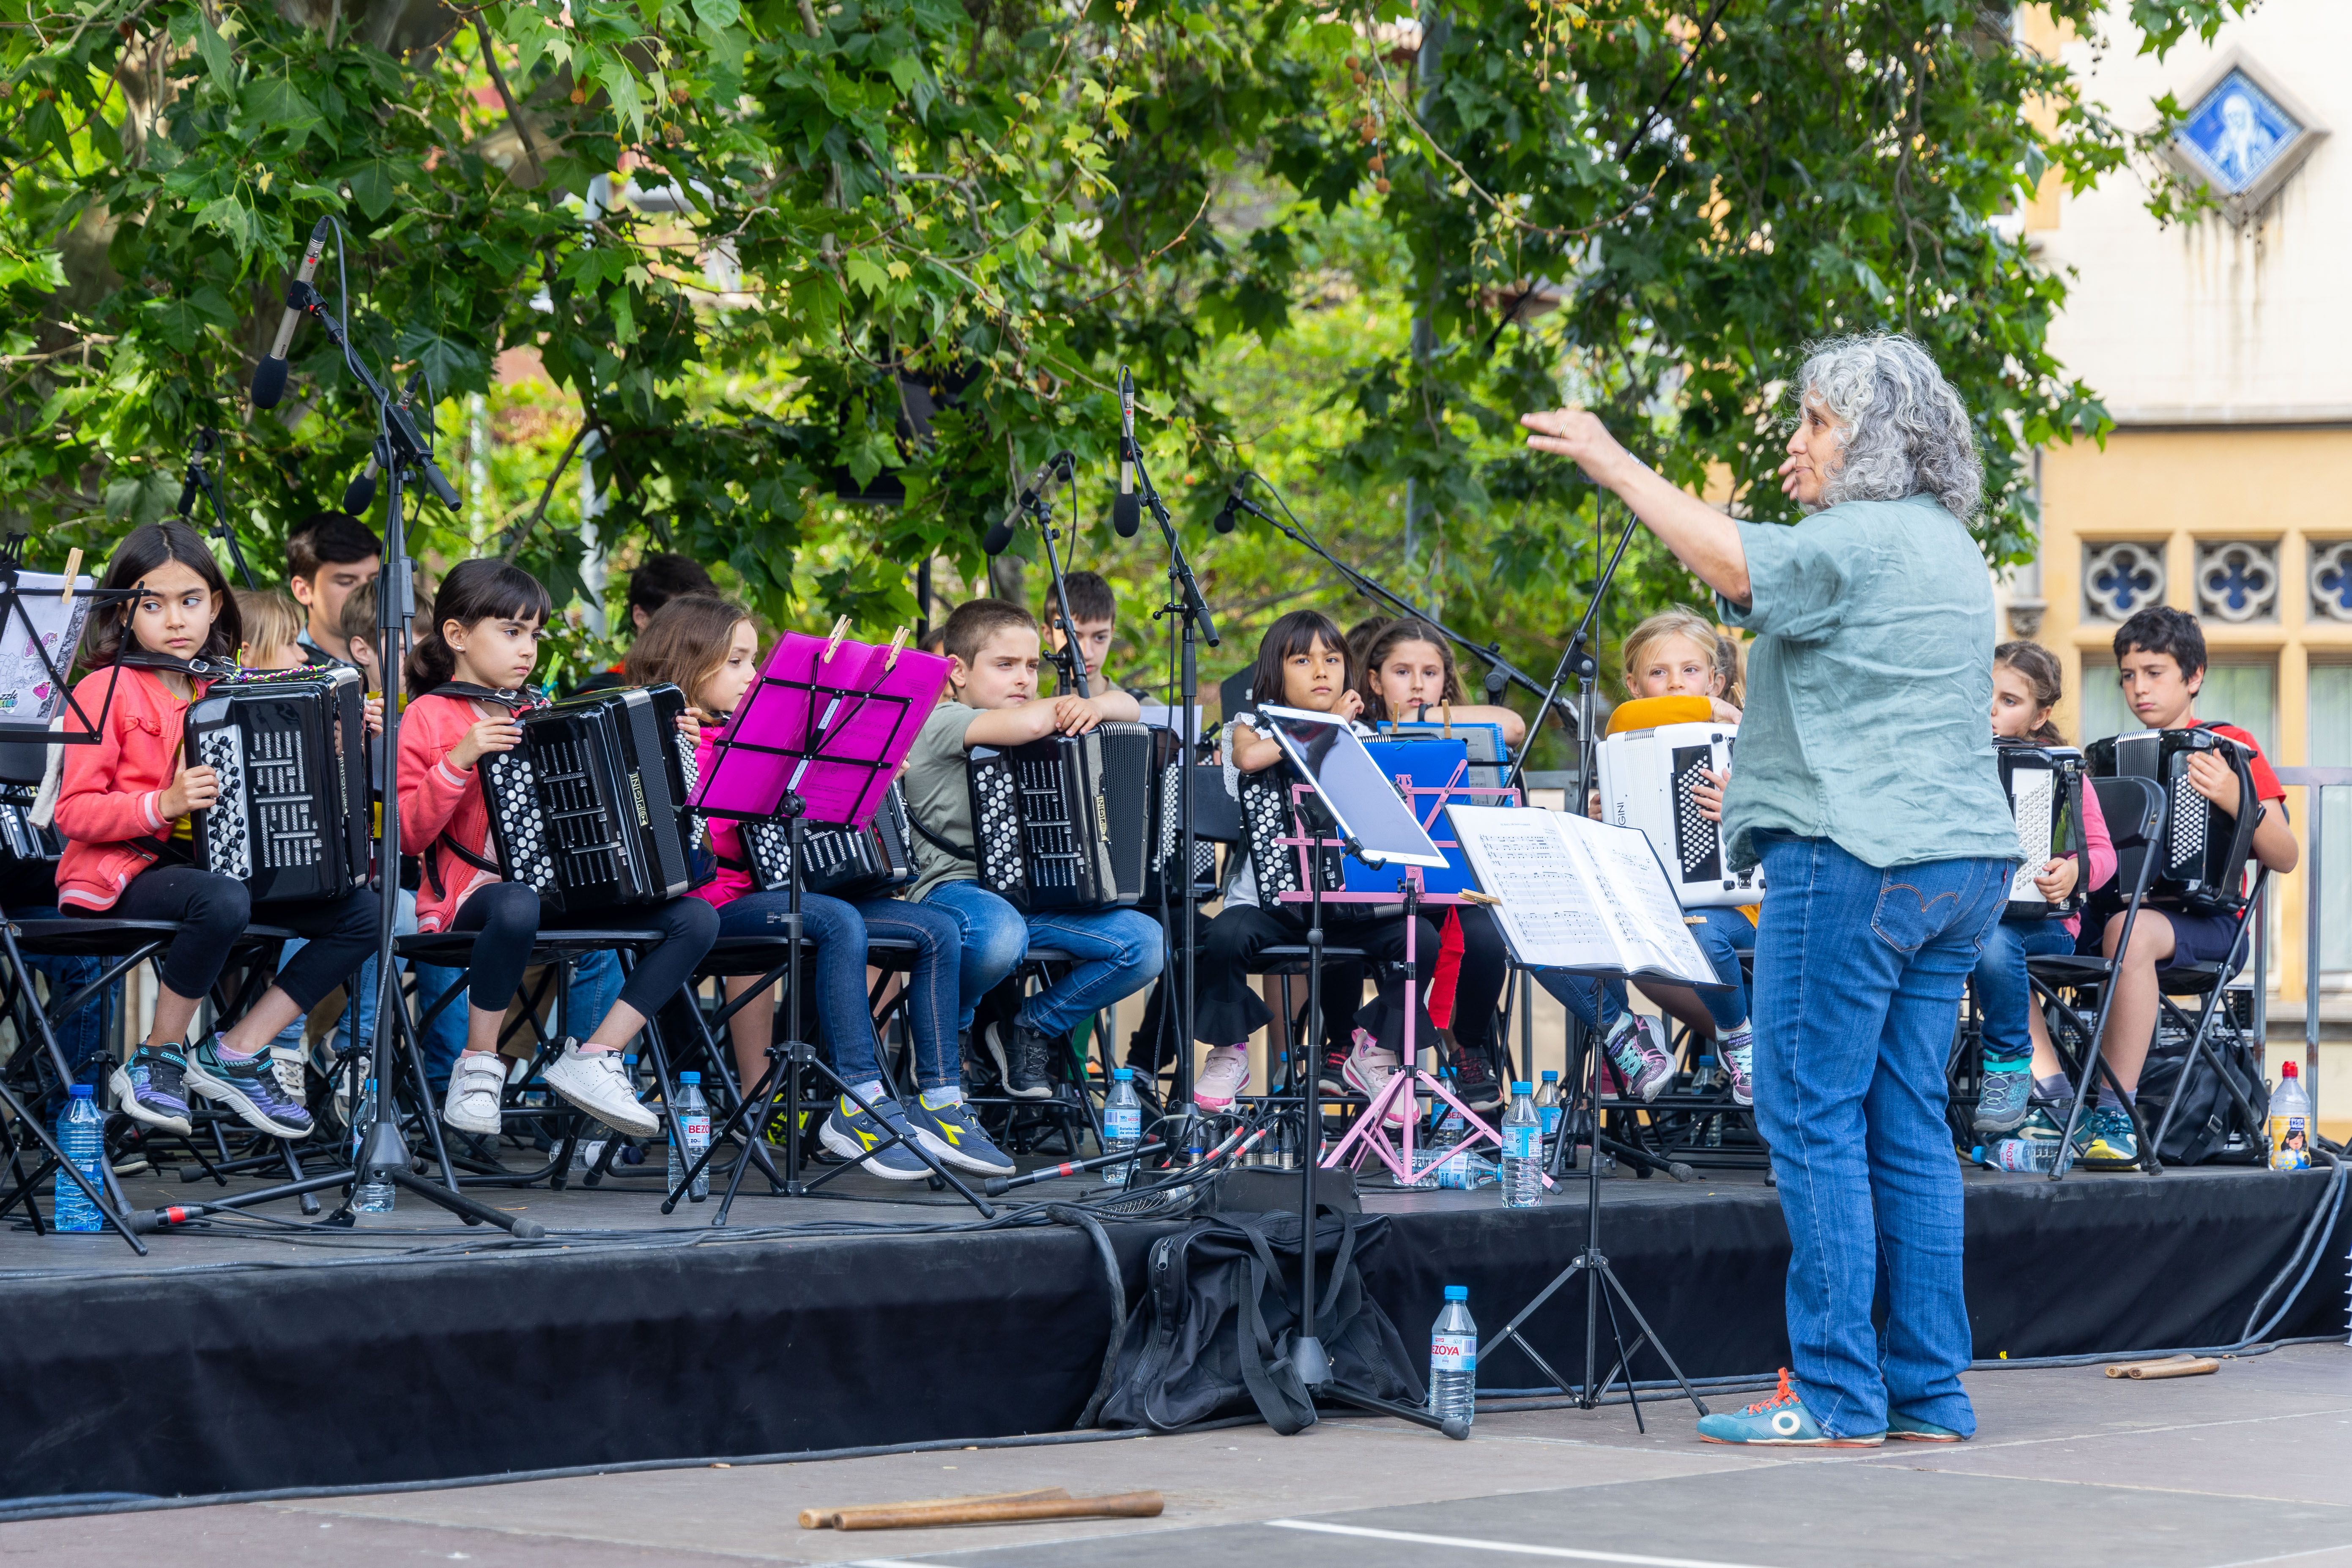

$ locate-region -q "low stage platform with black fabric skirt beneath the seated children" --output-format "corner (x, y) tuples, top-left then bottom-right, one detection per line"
(0, 1152), (2352, 1509)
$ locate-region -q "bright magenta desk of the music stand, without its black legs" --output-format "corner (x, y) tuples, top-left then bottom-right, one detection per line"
(692, 632), (948, 827)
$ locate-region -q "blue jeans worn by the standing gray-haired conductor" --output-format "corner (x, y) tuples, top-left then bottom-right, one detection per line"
(1755, 832), (2013, 1437)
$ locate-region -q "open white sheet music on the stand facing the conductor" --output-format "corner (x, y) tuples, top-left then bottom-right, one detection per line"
(1446, 806), (1720, 988)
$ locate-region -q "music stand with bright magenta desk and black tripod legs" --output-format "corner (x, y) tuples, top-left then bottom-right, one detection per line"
(661, 616), (997, 1229)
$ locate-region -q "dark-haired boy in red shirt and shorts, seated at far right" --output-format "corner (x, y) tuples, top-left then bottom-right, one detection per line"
(2077, 604), (2298, 1168)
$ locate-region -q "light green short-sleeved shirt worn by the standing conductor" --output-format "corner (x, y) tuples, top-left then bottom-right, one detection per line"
(1717, 496), (2018, 870)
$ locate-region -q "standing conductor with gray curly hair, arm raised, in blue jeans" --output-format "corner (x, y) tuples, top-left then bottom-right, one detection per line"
(1522, 336), (2018, 1448)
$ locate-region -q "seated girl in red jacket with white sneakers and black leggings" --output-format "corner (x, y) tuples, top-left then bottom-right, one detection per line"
(400, 559), (720, 1138)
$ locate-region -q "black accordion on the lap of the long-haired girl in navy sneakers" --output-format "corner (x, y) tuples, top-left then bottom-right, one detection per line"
(186, 665), (374, 905)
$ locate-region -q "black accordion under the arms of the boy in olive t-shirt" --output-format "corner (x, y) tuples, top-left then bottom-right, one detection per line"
(972, 722), (1160, 914)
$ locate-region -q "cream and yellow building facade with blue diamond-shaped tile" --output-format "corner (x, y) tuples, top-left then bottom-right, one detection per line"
(2004, 0), (2352, 1138)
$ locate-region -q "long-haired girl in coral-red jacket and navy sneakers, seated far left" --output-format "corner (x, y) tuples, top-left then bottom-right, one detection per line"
(57, 522), (376, 1138)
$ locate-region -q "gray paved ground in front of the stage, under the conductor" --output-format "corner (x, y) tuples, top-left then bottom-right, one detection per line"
(0, 1345), (2352, 1568)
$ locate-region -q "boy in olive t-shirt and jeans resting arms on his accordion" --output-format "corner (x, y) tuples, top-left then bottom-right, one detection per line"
(901, 599), (1164, 1100)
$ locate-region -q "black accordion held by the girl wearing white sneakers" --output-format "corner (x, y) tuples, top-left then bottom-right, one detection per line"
(480, 687), (698, 914)
